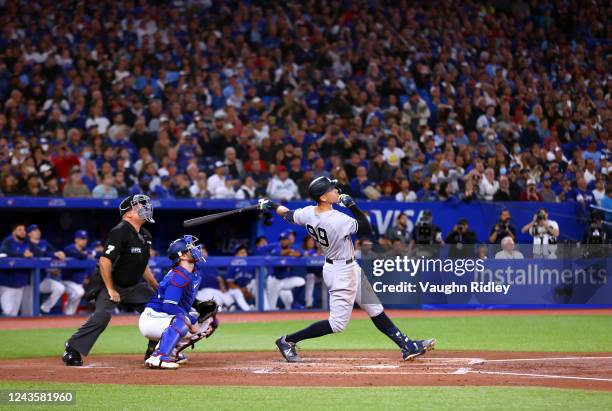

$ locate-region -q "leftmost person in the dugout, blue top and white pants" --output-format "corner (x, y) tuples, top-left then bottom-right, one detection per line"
(0, 223), (34, 317)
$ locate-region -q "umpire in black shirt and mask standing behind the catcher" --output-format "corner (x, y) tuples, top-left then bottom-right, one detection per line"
(62, 194), (158, 366)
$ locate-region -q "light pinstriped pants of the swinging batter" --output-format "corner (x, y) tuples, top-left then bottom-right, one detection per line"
(323, 261), (384, 333)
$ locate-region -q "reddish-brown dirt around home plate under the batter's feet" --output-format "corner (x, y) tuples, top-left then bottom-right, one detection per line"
(0, 351), (612, 391)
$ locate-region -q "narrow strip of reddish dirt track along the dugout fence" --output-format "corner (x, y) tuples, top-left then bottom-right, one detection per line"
(0, 309), (612, 330)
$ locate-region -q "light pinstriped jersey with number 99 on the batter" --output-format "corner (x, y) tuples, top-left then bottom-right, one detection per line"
(293, 206), (357, 260)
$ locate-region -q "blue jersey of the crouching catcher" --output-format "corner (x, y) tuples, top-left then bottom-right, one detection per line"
(147, 266), (202, 315)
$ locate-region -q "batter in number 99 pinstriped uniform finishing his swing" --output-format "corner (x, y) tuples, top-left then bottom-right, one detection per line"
(259, 177), (436, 362)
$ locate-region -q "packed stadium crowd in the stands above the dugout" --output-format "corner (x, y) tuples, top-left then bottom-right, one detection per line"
(0, 0), (612, 212)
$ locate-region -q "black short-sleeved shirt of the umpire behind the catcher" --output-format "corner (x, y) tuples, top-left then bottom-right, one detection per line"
(101, 221), (152, 287)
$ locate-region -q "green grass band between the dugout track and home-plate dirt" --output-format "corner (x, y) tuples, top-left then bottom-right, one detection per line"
(0, 315), (612, 358)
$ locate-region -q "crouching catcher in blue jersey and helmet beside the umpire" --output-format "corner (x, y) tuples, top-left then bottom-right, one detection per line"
(138, 235), (219, 369)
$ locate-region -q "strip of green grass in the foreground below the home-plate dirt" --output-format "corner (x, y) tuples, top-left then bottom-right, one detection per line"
(0, 382), (612, 411)
